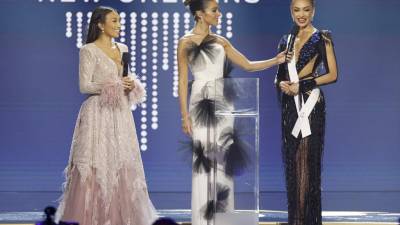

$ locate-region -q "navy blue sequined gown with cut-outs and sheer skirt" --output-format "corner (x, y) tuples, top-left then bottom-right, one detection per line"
(276, 30), (333, 225)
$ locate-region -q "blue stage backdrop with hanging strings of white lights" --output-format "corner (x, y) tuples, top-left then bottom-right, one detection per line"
(0, 0), (400, 211)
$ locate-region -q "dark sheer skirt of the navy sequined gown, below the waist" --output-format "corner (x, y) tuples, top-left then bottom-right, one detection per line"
(282, 91), (325, 225)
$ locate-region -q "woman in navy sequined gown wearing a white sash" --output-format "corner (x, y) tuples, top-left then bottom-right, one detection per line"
(276, 0), (337, 225)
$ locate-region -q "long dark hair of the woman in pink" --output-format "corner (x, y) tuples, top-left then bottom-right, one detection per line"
(86, 6), (117, 44)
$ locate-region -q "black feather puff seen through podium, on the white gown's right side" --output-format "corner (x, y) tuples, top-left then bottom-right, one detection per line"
(221, 129), (251, 177)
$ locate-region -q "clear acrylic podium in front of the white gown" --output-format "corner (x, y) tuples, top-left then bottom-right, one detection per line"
(207, 78), (259, 225)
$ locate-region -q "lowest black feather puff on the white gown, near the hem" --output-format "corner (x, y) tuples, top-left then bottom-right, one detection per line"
(204, 184), (230, 220)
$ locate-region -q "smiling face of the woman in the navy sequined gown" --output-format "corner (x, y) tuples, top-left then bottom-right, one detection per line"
(290, 0), (314, 28)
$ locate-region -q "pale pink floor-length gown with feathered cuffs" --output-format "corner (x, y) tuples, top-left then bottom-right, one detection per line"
(56, 43), (156, 225)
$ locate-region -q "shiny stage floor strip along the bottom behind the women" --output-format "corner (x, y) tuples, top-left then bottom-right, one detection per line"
(0, 210), (400, 225)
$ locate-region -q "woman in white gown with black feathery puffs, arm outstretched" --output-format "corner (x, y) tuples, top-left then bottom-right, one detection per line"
(177, 0), (291, 225)
